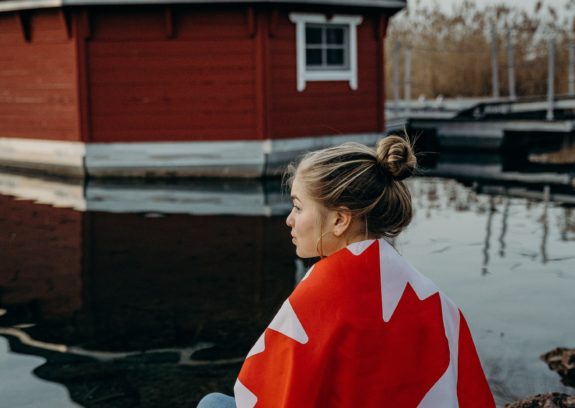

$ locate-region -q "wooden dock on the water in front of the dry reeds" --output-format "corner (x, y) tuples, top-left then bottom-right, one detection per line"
(387, 96), (575, 150)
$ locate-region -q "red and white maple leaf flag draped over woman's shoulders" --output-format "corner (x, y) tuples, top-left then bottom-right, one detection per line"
(234, 239), (495, 408)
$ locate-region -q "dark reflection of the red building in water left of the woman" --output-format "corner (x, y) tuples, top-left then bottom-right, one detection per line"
(0, 175), (305, 406)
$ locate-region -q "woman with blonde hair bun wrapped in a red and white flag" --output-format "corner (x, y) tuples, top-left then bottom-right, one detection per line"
(200, 136), (495, 408)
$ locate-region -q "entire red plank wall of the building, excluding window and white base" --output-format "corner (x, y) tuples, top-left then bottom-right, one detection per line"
(0, 4), (392, 142)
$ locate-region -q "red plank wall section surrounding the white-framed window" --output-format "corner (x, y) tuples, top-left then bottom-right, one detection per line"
(269, 10), (381, 139)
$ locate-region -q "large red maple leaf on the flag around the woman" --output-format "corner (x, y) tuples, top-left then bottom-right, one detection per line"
(239, 241), (450, 408)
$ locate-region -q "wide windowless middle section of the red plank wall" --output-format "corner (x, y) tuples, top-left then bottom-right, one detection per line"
(88, 6), (263, 142)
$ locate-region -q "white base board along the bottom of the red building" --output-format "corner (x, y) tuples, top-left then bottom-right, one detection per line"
(0, 133), (383, 178)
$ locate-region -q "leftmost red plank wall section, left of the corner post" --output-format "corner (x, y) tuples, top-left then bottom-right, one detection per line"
(0, 9), (80, 141)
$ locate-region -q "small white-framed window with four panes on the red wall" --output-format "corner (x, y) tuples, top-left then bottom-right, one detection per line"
(289, 13), (363, 92)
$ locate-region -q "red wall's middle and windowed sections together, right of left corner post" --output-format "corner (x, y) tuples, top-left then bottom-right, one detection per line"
(83, 5), (383, 142)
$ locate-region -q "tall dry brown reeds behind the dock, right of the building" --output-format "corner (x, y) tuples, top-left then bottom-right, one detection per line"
(386, 0), (570, 98)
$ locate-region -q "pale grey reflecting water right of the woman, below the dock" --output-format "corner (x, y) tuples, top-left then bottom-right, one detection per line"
(399, 178), (575, 405)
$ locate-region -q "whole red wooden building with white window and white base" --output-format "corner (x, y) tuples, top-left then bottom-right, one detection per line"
(0, 0), (406, 177)
